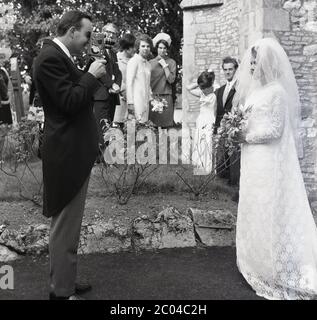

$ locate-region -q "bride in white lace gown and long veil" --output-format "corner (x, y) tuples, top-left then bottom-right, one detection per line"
(236, 38), (317, 299)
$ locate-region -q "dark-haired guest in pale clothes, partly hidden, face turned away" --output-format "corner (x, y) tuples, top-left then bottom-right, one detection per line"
(113, 33), (136, 124)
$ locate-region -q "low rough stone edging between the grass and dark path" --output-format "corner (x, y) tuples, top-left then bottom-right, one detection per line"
(0, 207), (235, 261)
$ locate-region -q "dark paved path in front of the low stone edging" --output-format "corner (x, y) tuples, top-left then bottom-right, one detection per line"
(0, 248), (260, 300)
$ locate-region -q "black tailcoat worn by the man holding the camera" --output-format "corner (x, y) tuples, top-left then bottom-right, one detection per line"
(34, 40), (100, 217)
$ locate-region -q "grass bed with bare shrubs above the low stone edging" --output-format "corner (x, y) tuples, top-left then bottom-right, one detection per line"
(0, 161), (237, 229)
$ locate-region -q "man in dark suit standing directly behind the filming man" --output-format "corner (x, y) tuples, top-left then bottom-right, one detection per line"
(94, 23), (122, 148)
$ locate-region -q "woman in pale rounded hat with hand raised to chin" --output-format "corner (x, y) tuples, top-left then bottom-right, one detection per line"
(149, 33), (176, 128)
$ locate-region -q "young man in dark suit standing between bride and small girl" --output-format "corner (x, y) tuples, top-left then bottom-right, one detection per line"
(215, 57), (240, 189)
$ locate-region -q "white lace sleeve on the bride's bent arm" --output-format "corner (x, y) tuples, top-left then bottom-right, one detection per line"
(246, 93), (285, 144)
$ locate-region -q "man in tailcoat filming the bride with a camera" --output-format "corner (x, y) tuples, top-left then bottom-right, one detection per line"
(34, 11), (106, 300)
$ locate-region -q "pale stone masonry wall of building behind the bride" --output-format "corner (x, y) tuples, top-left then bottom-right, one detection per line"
(182, 0), (317, 212)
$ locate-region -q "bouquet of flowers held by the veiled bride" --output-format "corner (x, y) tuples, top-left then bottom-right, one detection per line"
(214, 107), (249, 155)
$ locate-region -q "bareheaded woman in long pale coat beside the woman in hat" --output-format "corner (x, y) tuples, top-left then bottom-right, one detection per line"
(127, 34), (153, 122)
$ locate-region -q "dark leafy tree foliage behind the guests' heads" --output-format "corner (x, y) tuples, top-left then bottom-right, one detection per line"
(0, 0), (183, 73)
